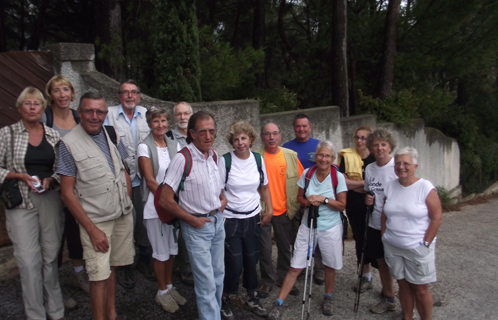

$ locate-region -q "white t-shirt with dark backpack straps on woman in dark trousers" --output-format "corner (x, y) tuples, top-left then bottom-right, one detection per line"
(218, 151), (268, 219)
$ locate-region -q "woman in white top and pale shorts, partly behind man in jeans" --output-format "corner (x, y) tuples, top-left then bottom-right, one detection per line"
(137, 107), (186, 313)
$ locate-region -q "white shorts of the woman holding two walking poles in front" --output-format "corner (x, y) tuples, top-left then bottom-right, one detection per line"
(291, 223), (342, 270)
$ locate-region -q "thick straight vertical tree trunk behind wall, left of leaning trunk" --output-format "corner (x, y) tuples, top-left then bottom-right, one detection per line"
(332, 0), (349, 117)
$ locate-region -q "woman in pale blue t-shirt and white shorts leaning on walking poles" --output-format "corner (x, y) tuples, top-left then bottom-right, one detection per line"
(269, 141), (347, 320)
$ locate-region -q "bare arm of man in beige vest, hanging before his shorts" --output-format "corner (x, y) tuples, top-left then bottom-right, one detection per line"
(61, 175), (109, 253)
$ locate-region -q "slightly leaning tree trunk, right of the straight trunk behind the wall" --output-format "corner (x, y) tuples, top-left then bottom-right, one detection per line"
(378, 0), (401, 99)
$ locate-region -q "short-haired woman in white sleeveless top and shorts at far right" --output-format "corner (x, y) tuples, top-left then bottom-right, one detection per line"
(382, 147), (443, 320)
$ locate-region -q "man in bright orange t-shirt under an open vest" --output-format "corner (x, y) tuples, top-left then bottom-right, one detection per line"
(258, 123), (304, 298)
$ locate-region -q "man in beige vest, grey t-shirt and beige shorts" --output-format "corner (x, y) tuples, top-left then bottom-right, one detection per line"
(57, 92), (135, 320)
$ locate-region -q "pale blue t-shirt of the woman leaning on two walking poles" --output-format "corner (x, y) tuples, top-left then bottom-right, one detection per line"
(297, 169), (348, 231)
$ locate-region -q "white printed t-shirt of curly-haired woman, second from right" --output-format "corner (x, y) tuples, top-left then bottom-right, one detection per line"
(365, 157), (398, 230)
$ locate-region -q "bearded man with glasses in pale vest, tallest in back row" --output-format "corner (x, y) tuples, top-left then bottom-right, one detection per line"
(104, 80), (156, 289)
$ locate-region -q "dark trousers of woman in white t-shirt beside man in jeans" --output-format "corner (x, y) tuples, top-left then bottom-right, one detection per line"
(223, 214), (261, 294)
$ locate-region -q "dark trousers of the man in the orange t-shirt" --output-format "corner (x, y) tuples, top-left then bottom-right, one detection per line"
(259, 213), (291, 287)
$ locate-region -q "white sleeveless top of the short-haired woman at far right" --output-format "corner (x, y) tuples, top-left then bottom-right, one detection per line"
(384, 179), (434, 249)
